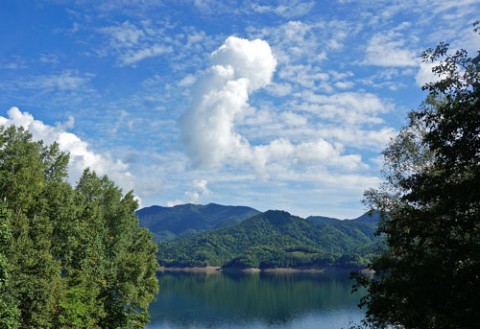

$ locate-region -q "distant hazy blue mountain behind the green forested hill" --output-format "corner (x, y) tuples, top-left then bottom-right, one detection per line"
(137, 203), (260, 242)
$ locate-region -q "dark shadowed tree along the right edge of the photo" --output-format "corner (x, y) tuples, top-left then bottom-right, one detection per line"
(357, 23), (480, 329)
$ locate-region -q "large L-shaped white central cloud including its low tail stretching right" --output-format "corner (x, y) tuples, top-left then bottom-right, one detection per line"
(179, 37), (368, 177)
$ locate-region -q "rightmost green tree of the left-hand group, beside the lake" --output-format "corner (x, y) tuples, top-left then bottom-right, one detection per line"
(77, 170), (158, 328)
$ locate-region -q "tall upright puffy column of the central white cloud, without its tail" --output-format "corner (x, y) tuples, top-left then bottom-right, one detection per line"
(180, 37), (276, 166)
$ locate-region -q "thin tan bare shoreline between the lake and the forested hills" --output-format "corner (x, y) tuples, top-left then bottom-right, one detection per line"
(158, 266), (373, 274)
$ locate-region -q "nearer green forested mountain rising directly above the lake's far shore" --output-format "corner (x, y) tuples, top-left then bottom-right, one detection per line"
(158, 211), (381, 268)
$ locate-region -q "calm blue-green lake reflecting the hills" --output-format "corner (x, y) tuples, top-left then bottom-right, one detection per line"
(146, 273), (364, 329)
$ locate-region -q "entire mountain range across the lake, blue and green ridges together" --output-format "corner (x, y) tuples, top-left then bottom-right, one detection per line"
(137, 203), (382, 269)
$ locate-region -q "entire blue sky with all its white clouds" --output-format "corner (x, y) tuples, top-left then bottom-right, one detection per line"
(0, 0), (480, 218)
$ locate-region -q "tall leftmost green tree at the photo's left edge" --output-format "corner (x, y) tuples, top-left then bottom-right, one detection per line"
(0, 127), (61, 328)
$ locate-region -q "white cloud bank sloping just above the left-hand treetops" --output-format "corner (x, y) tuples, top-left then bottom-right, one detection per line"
(0, 107), (134, 191)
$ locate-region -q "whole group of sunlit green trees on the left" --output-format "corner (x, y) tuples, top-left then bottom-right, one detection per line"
(0, 127), (158, 328)
